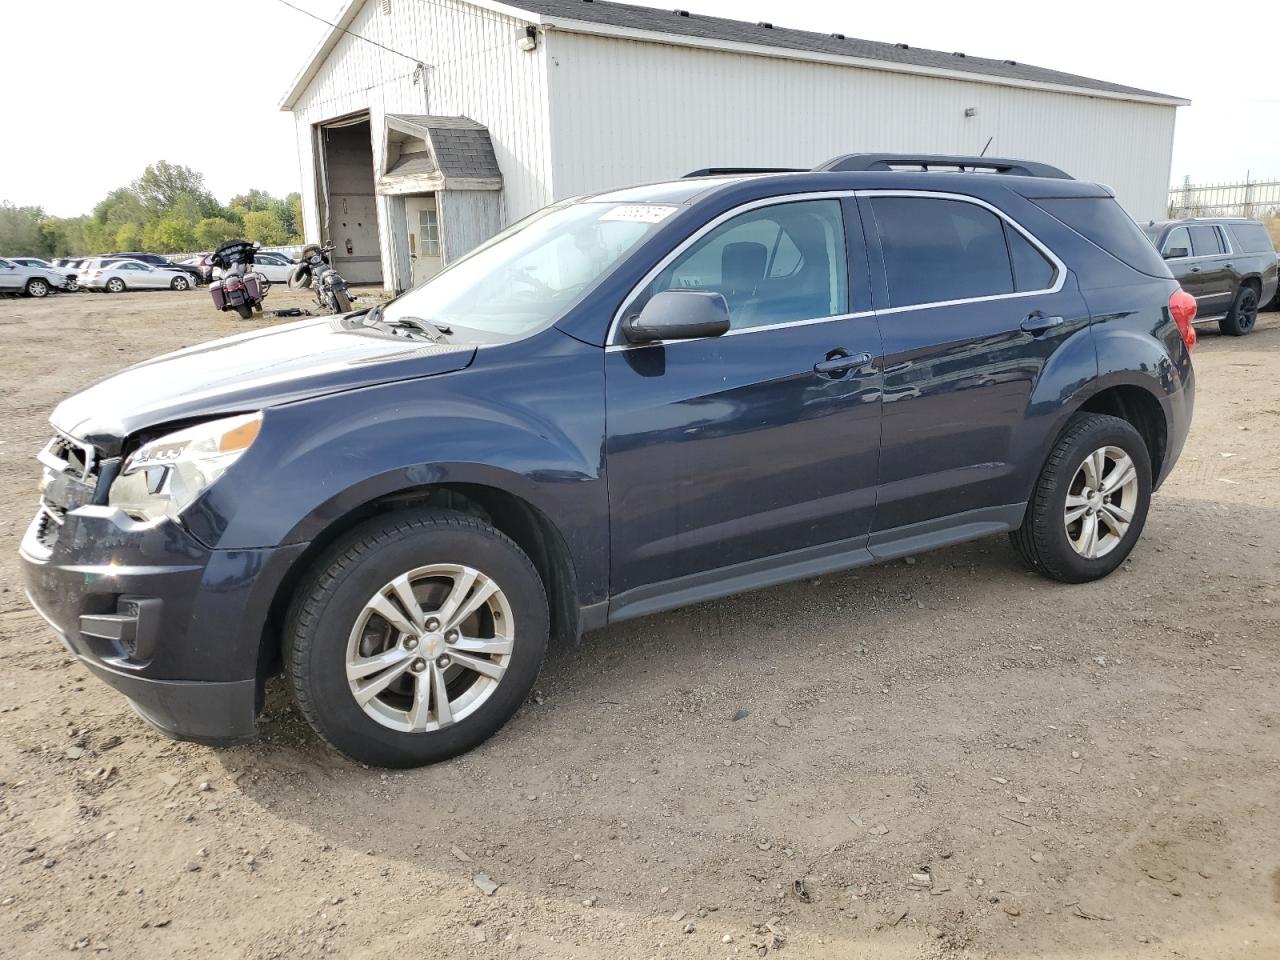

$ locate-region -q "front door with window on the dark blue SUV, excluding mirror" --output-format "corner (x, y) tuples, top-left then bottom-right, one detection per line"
(605, 200), (881, 613)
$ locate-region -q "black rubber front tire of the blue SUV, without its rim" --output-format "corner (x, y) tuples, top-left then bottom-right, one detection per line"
(287, 521), (548, 767)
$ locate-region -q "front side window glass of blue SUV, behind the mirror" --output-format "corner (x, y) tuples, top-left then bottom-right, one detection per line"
(645, 200), (849, 329)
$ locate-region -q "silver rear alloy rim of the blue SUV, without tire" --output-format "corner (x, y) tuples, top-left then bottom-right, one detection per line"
(1062, 447), (1138, 559)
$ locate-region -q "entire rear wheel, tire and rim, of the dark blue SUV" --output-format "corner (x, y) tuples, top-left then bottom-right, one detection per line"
(1009, 413), (1151, 584)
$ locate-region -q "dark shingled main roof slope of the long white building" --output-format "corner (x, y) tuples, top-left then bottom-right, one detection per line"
(509, 0), (1185, 102)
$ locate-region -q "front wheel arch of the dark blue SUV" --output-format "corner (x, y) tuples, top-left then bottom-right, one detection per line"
(257, 481), (586, 689)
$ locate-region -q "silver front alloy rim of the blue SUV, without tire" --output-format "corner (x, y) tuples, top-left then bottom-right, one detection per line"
(346, 563), (516, 733)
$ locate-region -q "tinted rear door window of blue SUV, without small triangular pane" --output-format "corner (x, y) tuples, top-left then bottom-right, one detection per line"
(870, 197), (1014, 307)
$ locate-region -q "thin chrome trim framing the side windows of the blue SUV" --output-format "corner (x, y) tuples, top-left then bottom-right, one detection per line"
(604, 188), (1066, 352)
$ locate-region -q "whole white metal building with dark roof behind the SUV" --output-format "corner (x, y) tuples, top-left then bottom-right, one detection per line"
(280, 0), (1188, 289)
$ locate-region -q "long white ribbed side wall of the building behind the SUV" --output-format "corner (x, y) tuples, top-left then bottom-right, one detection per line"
(545, 31), (1175, 219)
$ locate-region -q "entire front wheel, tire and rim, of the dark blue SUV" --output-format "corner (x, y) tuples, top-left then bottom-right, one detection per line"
(284, 509), (548, 767)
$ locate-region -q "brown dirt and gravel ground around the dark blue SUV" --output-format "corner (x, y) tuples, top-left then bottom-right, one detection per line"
(0, 289), (1280, 960)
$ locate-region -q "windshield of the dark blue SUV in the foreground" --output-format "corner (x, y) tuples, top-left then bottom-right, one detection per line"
(381, 201), (678, 337)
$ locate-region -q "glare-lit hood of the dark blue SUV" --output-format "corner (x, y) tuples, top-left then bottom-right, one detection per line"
(50, 316), (476, 456)
